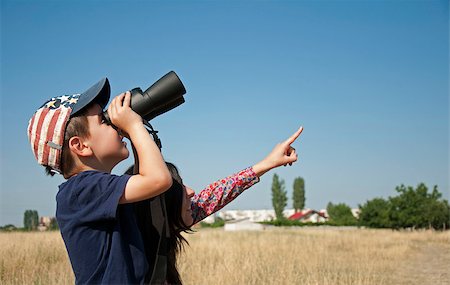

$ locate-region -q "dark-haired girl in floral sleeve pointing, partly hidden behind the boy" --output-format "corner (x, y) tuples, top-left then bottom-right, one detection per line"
(132, 127), (303, 284)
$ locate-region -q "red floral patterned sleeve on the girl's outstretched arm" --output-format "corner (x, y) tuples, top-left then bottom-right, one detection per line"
(191, 167), (259, 224)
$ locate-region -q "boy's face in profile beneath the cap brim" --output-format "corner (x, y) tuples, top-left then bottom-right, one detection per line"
(87, 104), (129, 172)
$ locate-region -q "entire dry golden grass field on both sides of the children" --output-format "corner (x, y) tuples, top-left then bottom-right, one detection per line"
(0, 228), (450, 285)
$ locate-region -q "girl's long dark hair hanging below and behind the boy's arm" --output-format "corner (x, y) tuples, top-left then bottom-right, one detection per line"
(126, 162), (192, 284)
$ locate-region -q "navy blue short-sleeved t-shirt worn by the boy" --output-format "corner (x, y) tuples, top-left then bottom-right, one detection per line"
(56, 171), (148, 284)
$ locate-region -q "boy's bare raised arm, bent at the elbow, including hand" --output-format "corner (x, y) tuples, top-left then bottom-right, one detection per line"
(108, 92), (172, 204)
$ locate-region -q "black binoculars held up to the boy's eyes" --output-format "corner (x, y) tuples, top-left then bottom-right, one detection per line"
(103, 71), (186, 123)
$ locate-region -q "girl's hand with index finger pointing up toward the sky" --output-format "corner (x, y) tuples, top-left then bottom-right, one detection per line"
(253, 127), (303, 176)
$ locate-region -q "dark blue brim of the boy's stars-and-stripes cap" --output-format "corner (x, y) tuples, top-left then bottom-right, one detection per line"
(70, 77), (111, 117)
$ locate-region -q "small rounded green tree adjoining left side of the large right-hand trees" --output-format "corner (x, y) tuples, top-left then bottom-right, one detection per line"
(359, 198), (391, 228)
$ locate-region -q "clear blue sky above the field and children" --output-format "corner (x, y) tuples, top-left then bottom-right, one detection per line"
(0, 0), (449, 226)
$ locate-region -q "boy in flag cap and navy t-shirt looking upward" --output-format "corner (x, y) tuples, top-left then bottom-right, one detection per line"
(28, 78), (172, 284)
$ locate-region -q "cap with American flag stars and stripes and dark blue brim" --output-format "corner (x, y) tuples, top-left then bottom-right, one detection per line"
(27, 78), (111, 173)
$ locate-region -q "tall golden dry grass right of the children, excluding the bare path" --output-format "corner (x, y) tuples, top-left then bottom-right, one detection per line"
(180, 228), (450, 285)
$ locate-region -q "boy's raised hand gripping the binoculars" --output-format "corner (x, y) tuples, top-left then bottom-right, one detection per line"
(108, 91), (142, 137)
